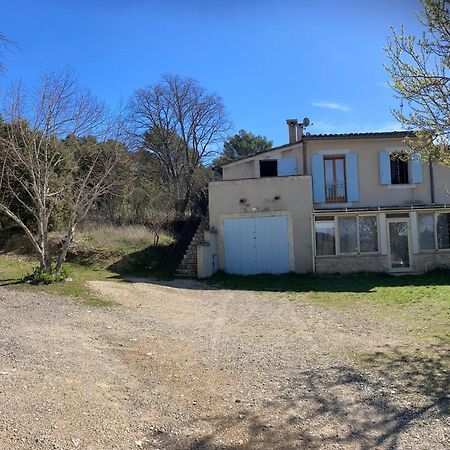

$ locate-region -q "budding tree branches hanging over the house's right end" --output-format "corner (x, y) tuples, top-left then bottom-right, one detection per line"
(386, 0), (450, 165)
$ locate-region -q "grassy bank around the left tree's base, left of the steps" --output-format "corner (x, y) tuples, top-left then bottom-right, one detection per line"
(0, 226), (179, 307)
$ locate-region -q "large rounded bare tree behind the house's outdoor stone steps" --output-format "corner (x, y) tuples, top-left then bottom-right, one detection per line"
(129, 75), (230, 215)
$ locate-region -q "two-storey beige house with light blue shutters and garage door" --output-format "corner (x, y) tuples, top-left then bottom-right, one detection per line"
(197, 120), (450, 277)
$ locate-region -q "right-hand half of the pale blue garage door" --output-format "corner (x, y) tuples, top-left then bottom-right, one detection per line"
(255, 216), (289, 273)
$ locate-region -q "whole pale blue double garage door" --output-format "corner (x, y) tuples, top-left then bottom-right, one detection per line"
(223, 216), (289, 275)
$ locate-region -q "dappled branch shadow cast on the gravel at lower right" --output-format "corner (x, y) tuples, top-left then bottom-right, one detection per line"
(150, 348), (450, 450)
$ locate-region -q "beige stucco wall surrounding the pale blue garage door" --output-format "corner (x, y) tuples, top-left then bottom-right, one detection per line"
(209, 176), (312, 273)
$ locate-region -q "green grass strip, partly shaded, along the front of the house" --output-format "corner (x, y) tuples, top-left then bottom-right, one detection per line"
(207, 272), (450, 343)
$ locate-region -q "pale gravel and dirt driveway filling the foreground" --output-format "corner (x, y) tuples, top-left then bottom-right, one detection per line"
(0, 281), (450, 450)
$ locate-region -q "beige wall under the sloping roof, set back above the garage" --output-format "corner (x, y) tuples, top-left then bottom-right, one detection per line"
(223, 143), (303, 180)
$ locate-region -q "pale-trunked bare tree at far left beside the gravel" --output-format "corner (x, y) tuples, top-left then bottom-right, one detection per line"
(0, 71), (126, 276)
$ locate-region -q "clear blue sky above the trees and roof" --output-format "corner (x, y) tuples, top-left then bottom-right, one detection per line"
(0, 0), (419, 145)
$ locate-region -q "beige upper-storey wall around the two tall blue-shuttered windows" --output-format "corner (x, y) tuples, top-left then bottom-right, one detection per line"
(307, 139), (450, 208)
